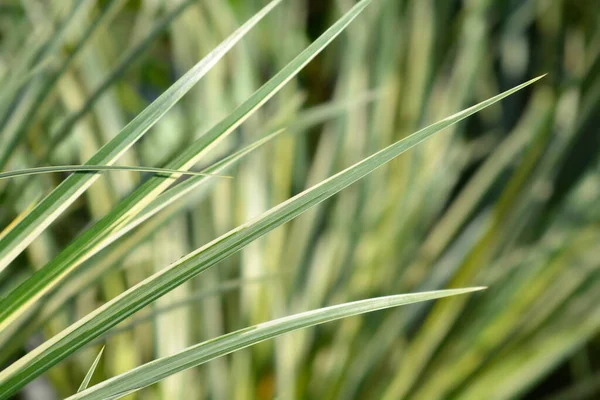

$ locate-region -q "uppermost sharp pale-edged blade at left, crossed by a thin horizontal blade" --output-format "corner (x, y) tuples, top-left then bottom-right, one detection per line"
(0, 0), (280, 278)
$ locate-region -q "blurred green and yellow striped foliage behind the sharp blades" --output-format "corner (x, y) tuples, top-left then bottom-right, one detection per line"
(0, 0), (600, 399)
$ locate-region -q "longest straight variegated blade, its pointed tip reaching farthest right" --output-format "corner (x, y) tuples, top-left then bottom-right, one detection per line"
(0, 75), (541, 397)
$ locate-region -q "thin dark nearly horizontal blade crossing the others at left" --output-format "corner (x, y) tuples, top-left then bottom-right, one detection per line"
(0, 164), (231, 179)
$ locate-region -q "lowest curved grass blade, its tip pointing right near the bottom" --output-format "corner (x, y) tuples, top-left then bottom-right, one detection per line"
(69, 287), (485, 400)
